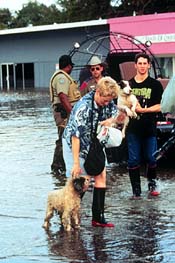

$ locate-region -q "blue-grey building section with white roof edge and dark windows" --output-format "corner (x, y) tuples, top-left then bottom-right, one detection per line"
(0, 20), (108, 90)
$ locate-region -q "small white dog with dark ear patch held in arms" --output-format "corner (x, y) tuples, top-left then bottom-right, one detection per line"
(117, 80), (138, 138)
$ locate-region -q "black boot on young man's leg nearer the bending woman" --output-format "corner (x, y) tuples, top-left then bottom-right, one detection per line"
(129, 167), (141, 199)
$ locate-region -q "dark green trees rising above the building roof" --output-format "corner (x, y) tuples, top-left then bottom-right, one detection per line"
(0, 0), (175, 29)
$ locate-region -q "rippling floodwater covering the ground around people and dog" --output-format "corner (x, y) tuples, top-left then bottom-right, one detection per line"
(0, 89), (175, 263)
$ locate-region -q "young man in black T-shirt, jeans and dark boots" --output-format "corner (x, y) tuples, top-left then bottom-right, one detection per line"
(127, 53), (163, 199)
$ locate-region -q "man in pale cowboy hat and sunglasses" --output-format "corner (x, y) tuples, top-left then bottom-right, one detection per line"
(80, 56), (104, 96)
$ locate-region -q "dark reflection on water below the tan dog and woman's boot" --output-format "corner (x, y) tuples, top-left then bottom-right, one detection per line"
(47, 229), (115, 263)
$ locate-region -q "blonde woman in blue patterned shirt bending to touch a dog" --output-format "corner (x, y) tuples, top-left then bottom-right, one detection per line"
(63, 77), (125, 227)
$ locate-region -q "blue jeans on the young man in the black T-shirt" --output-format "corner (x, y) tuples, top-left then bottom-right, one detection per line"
(127, 133), (157, 169)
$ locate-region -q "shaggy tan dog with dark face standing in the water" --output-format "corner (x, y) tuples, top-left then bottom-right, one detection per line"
(43, 177), (89, 231)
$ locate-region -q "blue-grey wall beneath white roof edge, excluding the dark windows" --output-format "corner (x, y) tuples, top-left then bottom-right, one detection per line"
(0, 25), (108, 88)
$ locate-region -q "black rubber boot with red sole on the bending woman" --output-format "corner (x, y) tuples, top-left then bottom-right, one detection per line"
(92, 187), (114, 227)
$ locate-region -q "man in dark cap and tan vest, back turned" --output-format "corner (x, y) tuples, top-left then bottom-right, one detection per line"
(50, 55), (81, 175)
